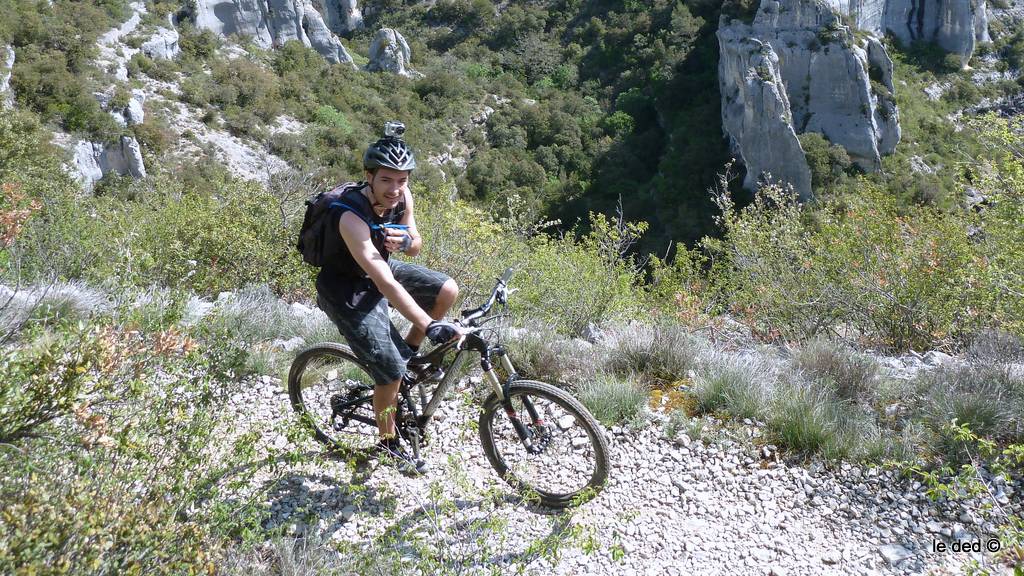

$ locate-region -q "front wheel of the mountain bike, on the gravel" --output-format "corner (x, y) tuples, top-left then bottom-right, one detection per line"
(479, 380), (610, 508)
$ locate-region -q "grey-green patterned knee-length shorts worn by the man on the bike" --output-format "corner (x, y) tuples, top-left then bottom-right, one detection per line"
(316, 259), (450, 385)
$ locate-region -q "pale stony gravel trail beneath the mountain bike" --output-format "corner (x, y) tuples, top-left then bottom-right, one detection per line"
(222, 377), (1024, 576)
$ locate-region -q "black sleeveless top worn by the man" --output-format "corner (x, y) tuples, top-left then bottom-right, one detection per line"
(316, 182), (406, 312)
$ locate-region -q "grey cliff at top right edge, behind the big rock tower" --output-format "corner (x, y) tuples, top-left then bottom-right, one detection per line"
(824, 0), (990, 66)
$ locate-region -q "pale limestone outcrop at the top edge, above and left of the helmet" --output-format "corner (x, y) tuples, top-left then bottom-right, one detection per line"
(195, 0), (354, 66)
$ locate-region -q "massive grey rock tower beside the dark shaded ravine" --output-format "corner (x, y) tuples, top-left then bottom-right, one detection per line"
(718, 0), (900, 197)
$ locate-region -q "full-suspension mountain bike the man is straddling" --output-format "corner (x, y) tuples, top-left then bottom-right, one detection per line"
(288, 269), (610, 507)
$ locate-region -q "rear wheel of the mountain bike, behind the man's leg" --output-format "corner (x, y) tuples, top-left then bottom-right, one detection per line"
(288, 342), (378, 450)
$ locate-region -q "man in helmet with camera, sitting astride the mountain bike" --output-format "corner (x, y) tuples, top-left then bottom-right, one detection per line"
(316, 122), (463, 474)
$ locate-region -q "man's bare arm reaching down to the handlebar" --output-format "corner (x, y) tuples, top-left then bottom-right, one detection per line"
(338, 212), (433, 330)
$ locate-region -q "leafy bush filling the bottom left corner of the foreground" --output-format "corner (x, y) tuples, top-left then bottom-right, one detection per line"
(0, 319), (268, 574)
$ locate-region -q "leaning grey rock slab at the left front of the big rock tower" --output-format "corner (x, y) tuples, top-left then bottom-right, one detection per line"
(718, 30), (811, 199)
